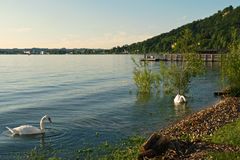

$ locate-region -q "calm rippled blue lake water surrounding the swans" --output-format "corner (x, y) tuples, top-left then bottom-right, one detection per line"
(0, 55), (219, 159)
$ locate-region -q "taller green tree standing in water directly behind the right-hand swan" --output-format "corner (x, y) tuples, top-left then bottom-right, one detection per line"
(160, 29), (204, 94)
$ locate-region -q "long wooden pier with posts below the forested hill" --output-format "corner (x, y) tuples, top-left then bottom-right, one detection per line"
(141, 54), (223, 62)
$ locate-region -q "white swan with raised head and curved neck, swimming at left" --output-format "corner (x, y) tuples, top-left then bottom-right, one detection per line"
(6, 115), (52, 135)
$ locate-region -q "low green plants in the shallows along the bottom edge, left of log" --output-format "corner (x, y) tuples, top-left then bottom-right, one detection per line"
(17, 136), (145, 160)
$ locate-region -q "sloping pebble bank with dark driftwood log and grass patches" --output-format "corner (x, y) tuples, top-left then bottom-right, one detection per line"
(138, 97), (240, 159)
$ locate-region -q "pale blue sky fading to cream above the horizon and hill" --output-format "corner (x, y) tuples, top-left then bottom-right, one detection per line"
(0, 0), (240, 49)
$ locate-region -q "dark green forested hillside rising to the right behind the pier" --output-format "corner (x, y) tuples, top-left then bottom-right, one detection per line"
(110, 6), (240, 54)
